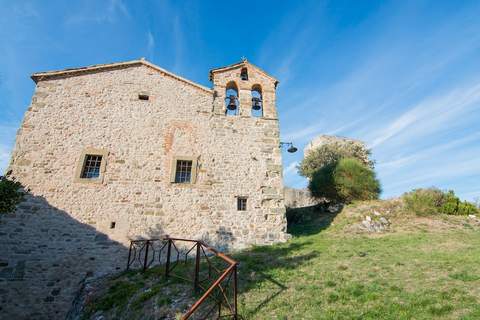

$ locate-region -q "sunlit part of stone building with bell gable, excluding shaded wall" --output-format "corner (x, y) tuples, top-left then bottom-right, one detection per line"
(8, 59), (288, 248)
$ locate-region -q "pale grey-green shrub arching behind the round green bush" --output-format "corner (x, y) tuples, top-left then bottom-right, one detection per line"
(298, 140), (374, 178)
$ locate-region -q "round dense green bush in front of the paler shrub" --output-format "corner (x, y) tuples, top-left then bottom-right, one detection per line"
(309, 158), (381, 203)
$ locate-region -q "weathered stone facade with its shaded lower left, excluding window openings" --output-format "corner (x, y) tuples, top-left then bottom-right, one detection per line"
(0, 60), (288, 319)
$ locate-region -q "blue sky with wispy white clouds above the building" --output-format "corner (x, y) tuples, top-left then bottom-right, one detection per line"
(0, 0), (480, 200)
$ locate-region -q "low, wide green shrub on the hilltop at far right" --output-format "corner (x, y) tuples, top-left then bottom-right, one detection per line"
(403, 188), (478, 216)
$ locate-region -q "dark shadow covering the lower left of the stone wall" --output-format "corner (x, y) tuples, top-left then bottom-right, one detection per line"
(0, 192), (165, 319)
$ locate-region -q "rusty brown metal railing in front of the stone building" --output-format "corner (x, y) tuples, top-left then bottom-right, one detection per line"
(127, 237), (238, 320)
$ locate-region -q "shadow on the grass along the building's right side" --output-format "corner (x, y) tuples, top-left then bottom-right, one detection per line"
(230, 203), (342, 318)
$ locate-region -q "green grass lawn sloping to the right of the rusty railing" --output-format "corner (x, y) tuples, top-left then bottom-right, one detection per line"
(236, 214), (480, 319)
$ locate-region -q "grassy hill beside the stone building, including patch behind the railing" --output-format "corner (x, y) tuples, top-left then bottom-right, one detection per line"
(75, 201), (480, 319)
